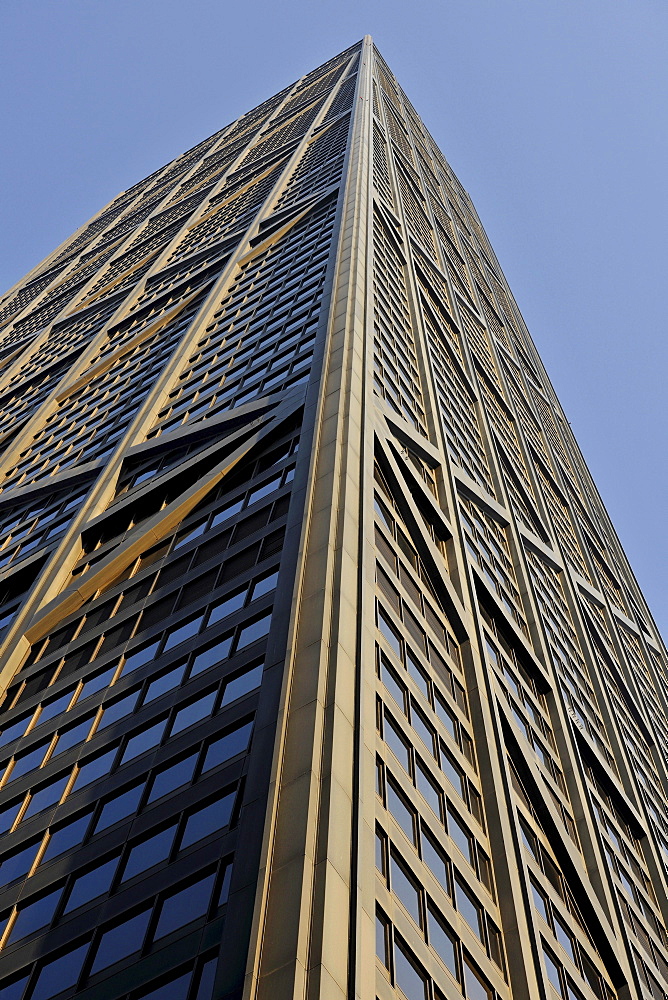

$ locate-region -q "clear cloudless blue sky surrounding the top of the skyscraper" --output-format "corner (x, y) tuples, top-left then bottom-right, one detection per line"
(0, 0), (668, 636)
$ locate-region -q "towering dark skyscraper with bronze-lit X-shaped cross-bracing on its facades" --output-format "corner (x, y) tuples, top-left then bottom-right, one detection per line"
(0, 38), (668, 1000)
